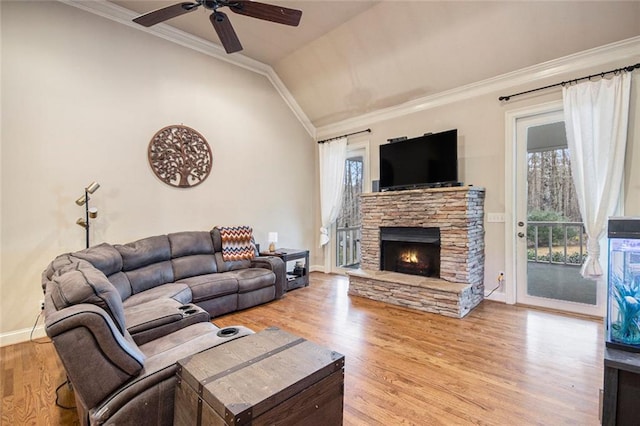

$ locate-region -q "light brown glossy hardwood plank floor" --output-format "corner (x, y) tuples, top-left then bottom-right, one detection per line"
(0, 273), (604, 425)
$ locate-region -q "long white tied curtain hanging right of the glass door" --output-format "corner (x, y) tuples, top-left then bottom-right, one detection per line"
(562, 73), (631, 278)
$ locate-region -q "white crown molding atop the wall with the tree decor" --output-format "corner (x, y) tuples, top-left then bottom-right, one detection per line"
(58, 0), (316, 138)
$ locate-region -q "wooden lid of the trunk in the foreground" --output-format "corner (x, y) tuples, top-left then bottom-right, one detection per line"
(178, 327), (344, 425)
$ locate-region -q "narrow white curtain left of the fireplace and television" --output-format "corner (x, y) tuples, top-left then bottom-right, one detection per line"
(318, 137), (347, 247)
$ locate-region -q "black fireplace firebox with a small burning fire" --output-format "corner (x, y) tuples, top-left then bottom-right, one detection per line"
(380, 227), (440, 278)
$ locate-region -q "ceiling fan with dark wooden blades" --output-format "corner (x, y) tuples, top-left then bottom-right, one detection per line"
(133, 0), (302, 53)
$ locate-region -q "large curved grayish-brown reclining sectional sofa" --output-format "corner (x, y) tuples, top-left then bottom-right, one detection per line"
(42, 228), (286, 425)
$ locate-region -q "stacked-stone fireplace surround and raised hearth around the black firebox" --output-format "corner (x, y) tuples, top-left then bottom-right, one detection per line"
(348, 186), (485, 318)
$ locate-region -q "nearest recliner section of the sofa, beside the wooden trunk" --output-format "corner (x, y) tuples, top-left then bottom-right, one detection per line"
(45, 296), (252, 425)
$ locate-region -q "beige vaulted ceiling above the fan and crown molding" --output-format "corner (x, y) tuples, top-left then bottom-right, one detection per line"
(113, 0), (640, 127)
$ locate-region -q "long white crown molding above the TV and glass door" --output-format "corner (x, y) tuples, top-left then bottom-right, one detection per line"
(316, 36), (640, 139)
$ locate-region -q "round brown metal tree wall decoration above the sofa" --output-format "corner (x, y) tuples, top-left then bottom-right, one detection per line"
(148, 125), (211, 188)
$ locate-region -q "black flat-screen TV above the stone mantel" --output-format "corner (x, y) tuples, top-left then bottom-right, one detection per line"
(380, 129), (458, 190)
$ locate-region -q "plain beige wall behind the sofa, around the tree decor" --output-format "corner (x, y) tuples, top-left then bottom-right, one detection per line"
(0, 2), (316, 343)
